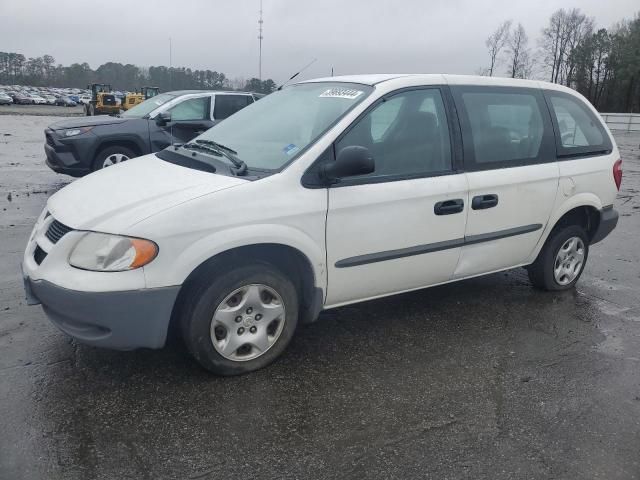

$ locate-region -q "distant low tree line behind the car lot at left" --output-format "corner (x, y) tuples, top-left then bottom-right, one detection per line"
(0, 52), (276, 93)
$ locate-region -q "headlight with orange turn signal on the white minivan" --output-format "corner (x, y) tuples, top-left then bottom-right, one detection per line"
(69, 232), (158, 272)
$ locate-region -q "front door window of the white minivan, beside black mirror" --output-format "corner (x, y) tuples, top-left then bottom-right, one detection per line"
(336, 88), (451, 178)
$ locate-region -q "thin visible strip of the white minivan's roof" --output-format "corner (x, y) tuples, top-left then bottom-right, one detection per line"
(300, 73), (573, 92)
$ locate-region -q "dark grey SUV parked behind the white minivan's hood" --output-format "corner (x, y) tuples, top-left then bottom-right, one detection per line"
(44, 90), (255, 177)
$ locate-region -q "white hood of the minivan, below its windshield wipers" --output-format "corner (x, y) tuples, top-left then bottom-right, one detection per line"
(47, 154), (250, 234)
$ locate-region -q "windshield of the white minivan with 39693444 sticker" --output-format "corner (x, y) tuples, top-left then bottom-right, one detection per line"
(195, 82), (373, 170)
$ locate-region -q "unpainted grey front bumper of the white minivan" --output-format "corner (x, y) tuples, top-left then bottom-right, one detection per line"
(24, 276), (180, 350)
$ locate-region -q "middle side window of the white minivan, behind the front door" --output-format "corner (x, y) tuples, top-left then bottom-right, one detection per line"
(456, 87), (553, 169)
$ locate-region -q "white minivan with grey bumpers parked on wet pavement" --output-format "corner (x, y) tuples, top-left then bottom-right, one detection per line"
(23, 75), (622, 375)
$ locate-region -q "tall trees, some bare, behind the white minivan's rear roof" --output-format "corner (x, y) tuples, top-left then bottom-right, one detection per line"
(480, 8), (640, 113)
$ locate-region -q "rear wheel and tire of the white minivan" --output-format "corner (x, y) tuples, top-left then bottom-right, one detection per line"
(527, 225), (589, 291)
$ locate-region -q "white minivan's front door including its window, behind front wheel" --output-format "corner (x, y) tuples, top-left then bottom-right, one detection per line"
(326, 88), (467, 305)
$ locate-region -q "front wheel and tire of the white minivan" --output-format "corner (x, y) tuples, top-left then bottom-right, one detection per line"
(180, 263), (298, 376)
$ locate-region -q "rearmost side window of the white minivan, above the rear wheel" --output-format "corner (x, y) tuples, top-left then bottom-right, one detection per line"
(546, 91), (611, 157)
